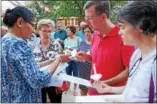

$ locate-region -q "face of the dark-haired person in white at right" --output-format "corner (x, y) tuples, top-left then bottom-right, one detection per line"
(118, 21), (141, 46)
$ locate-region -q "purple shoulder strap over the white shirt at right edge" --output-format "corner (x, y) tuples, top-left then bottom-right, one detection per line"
(148, 57), (157, 103)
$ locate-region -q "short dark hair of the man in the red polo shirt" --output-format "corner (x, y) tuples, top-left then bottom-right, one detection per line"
(83, 0), (110, 18)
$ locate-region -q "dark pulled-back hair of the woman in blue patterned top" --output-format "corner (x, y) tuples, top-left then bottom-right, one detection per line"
(3, 6), (34, 27)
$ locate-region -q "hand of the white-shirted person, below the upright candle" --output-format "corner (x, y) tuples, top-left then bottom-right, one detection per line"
(92, 81), (112, 93)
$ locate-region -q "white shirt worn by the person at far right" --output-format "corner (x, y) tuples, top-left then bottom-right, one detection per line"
(123, 49), (157, 102)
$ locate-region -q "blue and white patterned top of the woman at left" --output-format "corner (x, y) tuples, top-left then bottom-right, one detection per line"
(1, 33), (51, 103)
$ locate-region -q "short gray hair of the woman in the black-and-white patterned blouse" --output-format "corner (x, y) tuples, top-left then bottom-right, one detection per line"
(37, 19), (55, 29)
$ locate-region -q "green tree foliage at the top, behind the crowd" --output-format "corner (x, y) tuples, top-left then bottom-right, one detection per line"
(28, 0), (127, 22)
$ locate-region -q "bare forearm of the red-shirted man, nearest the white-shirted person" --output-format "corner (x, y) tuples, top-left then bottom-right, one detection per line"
(104, 69), (129, 86)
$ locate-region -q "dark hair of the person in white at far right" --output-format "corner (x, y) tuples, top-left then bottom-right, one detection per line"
(117, 0), (157, 35)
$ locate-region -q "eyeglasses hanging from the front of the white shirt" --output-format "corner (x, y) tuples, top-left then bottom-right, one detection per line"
(129, 57), (142, 77)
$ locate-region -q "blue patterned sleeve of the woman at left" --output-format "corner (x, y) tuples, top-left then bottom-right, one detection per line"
(10, 41), (51, 88)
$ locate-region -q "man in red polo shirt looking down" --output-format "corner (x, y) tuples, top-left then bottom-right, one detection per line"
(78, 1), (134, 95)
